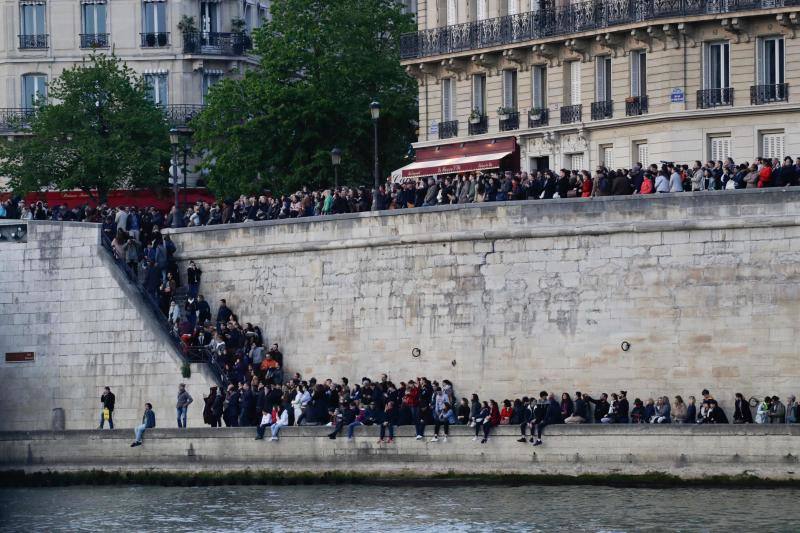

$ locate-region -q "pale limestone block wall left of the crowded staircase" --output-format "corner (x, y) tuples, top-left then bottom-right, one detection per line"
(0, 218), (213, 430)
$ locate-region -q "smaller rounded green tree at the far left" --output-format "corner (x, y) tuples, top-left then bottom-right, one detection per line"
(0, 54), (169, 202)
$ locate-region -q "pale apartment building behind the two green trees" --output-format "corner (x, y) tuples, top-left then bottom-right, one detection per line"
(0, 0), (270, 130)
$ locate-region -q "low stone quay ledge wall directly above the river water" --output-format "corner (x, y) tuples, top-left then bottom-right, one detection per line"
(0, 424), (800, 480)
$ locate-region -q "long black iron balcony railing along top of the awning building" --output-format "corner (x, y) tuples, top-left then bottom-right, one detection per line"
(400, 0), (788, 59)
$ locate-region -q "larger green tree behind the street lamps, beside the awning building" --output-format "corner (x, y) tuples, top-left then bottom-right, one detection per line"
(193, 0), (417, 196)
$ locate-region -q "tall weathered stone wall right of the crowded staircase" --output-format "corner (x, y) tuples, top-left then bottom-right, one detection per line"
(169, 189), (800, 414)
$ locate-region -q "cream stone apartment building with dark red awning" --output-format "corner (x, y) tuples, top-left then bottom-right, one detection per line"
(401, 0), (800, 177)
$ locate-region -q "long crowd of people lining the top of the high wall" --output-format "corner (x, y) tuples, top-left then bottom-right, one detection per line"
(0, 156), (800, 223)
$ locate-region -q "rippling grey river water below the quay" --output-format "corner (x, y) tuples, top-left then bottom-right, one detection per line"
(0, 484), (800, 533)
